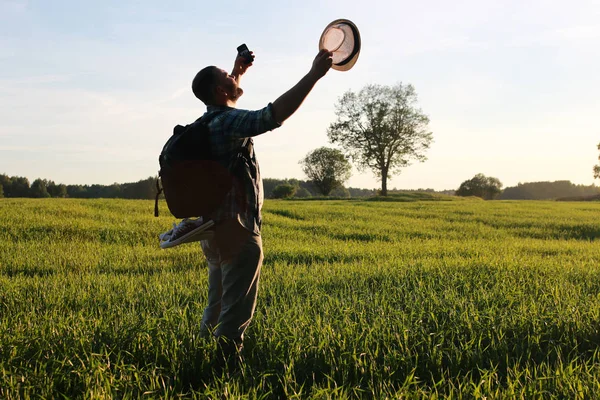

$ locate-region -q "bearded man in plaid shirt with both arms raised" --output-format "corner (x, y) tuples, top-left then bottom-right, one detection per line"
(192, 50), (332, 368)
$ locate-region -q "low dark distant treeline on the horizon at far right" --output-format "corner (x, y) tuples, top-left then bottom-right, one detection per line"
(497, 181), (600, 200)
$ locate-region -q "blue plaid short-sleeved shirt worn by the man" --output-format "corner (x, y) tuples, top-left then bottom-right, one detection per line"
(203, 104), (281, 234)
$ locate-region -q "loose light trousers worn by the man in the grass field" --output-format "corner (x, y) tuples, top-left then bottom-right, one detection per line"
(200, 220), (263, 343)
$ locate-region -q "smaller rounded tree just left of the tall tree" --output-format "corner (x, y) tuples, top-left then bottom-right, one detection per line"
(300, 147), (352, 196)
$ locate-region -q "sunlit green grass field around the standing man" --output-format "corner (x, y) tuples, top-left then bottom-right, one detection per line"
(0, 196), (600, 399)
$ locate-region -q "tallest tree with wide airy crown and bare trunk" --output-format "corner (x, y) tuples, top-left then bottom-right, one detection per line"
(327, 83), (433, 196)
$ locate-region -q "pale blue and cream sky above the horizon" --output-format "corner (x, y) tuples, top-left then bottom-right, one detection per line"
(0, 0), (600, 190)
